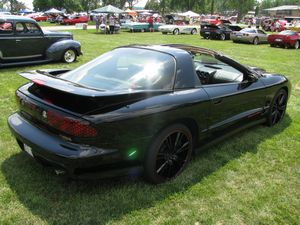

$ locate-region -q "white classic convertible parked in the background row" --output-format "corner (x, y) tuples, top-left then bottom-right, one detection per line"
(158, 24), (199, 35)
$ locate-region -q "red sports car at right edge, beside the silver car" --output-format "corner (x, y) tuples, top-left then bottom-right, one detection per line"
(268, 30), (300, 49)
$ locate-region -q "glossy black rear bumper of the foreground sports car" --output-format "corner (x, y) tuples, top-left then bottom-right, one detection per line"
(8, 113), (141, 178)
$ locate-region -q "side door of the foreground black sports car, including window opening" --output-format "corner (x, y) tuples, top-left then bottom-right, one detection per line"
(198, 53), (265, 133)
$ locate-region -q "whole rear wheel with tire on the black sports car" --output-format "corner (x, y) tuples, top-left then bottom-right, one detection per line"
(144, 124), (193, 184)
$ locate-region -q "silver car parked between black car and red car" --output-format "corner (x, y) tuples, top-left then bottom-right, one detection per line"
(230, 28), (268, 45)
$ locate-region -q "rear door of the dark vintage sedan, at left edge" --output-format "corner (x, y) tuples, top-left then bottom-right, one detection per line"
(0, 21), (17, 61)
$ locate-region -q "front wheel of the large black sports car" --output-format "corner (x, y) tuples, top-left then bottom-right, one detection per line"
(267, 89), (288, 127)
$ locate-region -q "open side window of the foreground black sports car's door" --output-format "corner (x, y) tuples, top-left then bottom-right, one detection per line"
(194, 54), (243, 85)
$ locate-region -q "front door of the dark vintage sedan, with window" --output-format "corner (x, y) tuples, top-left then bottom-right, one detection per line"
(15, 22), (47, 59)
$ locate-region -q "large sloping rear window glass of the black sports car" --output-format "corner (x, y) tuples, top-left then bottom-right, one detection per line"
(60, 48), (175, 91)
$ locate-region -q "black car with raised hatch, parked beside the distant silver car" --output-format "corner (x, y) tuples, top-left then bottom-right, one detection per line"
(200, 24), (242, 40)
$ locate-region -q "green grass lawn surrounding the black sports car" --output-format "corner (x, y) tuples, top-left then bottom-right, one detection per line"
(0, 30), (300, 225)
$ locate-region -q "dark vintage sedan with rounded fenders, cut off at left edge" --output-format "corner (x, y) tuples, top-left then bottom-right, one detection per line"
(0, 16), (82, 67)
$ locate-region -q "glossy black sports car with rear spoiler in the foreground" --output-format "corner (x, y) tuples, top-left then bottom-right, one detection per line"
(8, 45), (291, 183)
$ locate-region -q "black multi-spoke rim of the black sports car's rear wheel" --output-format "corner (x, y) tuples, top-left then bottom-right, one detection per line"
(155, 130), (192, 179)
